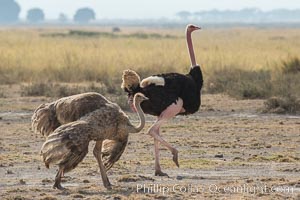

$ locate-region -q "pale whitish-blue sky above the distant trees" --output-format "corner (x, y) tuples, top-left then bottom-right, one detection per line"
(15, 0), (300, 19)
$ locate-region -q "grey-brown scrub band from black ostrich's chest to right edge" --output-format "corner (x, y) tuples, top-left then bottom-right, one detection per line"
(204, 58), (300, 99)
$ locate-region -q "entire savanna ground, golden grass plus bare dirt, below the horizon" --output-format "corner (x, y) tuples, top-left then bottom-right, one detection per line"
(0, 28), (300, 199)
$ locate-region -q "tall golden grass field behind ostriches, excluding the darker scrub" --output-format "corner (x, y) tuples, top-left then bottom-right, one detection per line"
(0, 27), (300, 83)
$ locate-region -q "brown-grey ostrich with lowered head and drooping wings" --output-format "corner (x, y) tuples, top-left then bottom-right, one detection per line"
(32, 93), (148, 190)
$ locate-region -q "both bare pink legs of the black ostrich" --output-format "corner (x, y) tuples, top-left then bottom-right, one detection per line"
(148, 98), (183, 175)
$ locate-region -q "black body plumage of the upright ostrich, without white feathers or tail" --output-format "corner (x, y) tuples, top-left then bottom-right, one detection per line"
(125, 66), (203, 116)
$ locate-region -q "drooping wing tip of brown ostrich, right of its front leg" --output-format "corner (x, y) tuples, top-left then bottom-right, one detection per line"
(102, 136), (128, 170)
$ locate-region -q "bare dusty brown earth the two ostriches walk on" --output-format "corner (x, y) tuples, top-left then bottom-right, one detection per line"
(0, 88), (300, 200)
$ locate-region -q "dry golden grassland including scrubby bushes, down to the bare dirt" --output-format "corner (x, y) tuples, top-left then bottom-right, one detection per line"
(0, 28), (300, 112)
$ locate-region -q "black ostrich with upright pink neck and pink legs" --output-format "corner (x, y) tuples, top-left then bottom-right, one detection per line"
(121, 24), (203, 176)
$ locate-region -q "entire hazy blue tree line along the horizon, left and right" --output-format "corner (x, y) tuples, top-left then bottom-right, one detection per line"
(0, 0), (300, 24)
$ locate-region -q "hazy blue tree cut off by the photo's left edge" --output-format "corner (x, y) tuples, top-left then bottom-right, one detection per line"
(0, 0), (21, 23)
